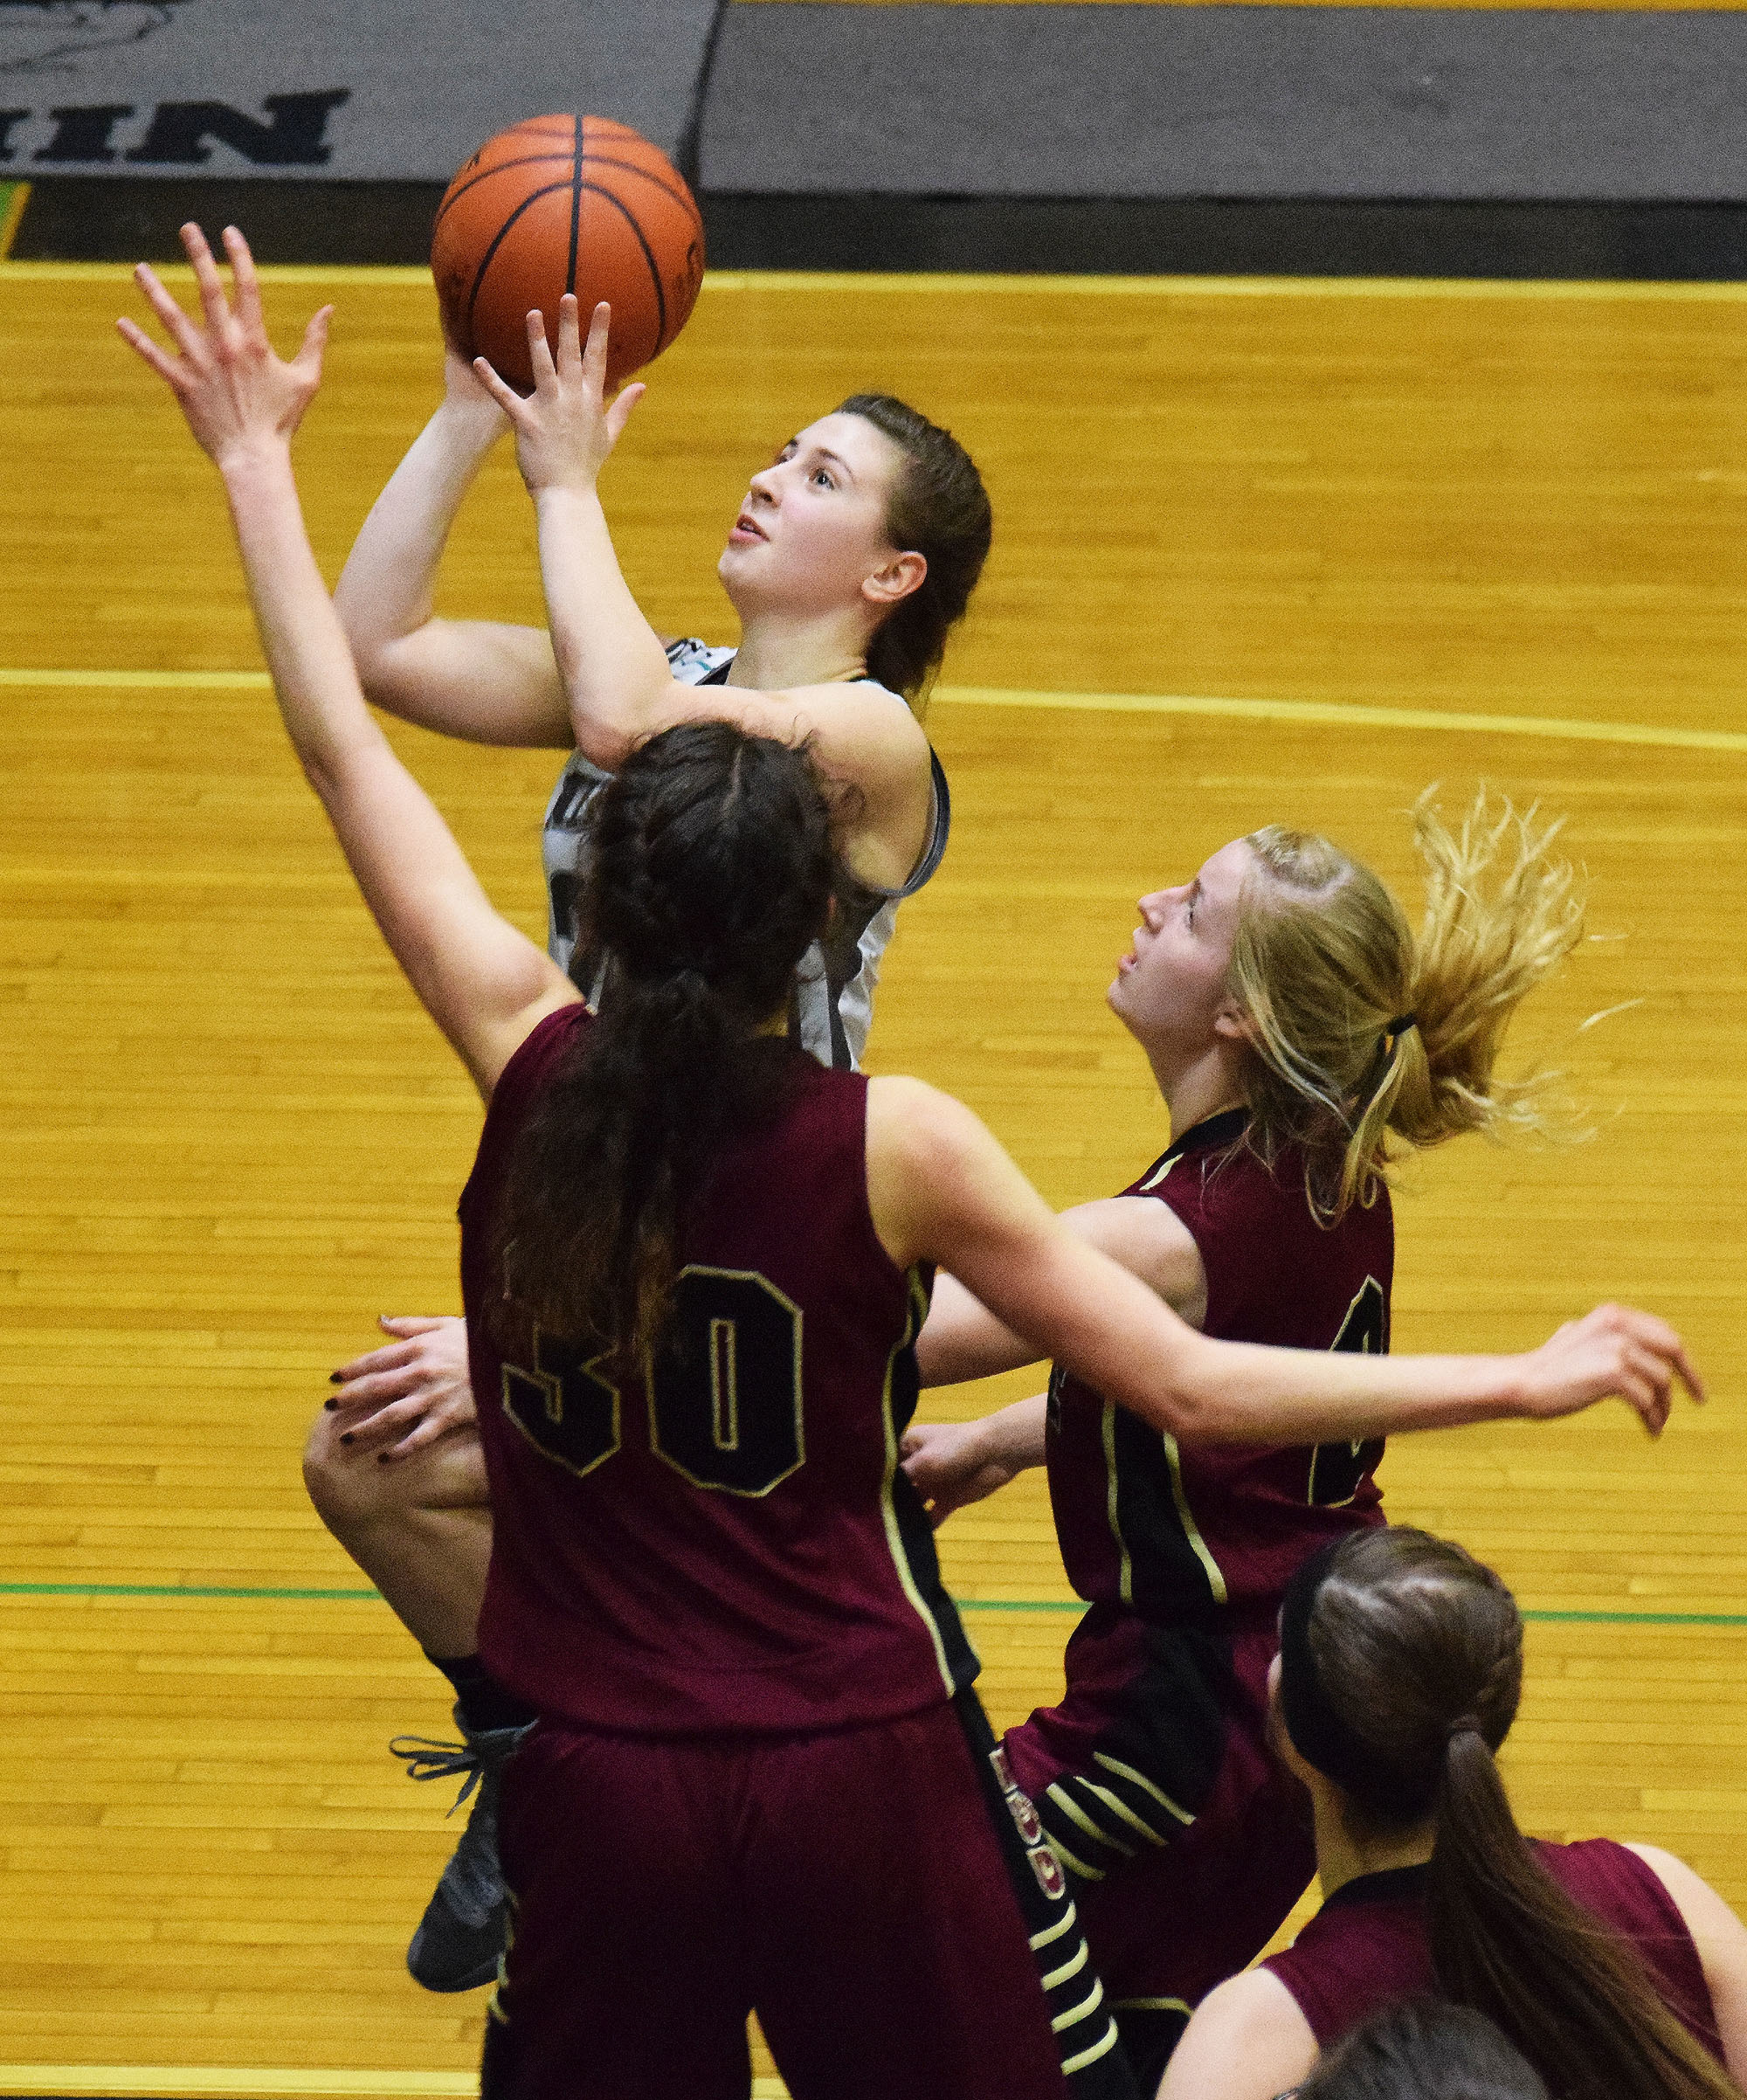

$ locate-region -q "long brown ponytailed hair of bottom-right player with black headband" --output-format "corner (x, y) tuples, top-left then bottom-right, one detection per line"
(1281, 1524), (1738, 2100)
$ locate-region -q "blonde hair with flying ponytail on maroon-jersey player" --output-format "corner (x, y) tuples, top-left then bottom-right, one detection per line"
(1228, 788), (1584, 1222)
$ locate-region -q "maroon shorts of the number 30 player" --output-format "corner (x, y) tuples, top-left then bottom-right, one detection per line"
(480, 1705), (1065, 2100)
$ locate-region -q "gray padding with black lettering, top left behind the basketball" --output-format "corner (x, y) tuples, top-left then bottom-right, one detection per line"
(0, 0), (716, 181)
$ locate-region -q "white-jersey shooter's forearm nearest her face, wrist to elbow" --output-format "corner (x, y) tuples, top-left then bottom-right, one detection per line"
(535, 487), (674, 770)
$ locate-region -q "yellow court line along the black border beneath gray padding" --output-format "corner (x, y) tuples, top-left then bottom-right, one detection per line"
(0, 263), (1747, 305)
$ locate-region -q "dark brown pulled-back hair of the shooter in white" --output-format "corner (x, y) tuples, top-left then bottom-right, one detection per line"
(833, 395), (995, 703)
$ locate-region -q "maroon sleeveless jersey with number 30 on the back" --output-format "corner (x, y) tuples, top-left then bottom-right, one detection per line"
(459, 1006), (977, 1735)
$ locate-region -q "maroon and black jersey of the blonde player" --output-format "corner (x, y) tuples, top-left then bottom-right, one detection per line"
(1048, 1109), (1394, 1638)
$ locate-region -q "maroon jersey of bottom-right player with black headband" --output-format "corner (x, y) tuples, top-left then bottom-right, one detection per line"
(1262, 1838), (1722, 2062)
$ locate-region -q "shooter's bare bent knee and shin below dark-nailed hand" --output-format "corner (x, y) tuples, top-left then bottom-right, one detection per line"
(302, 1409), (492, 1654)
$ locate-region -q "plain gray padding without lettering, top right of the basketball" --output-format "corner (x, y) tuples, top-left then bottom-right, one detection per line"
(703, 4), (1747, 202)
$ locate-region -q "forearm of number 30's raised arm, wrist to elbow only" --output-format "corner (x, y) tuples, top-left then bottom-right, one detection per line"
(223, 441), (383, 802)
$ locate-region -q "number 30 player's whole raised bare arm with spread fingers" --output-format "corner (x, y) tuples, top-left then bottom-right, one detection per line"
(118, 227), (577, 1096)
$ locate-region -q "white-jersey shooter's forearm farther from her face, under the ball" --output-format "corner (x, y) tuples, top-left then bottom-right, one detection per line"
(334, 401), (504, 680)
